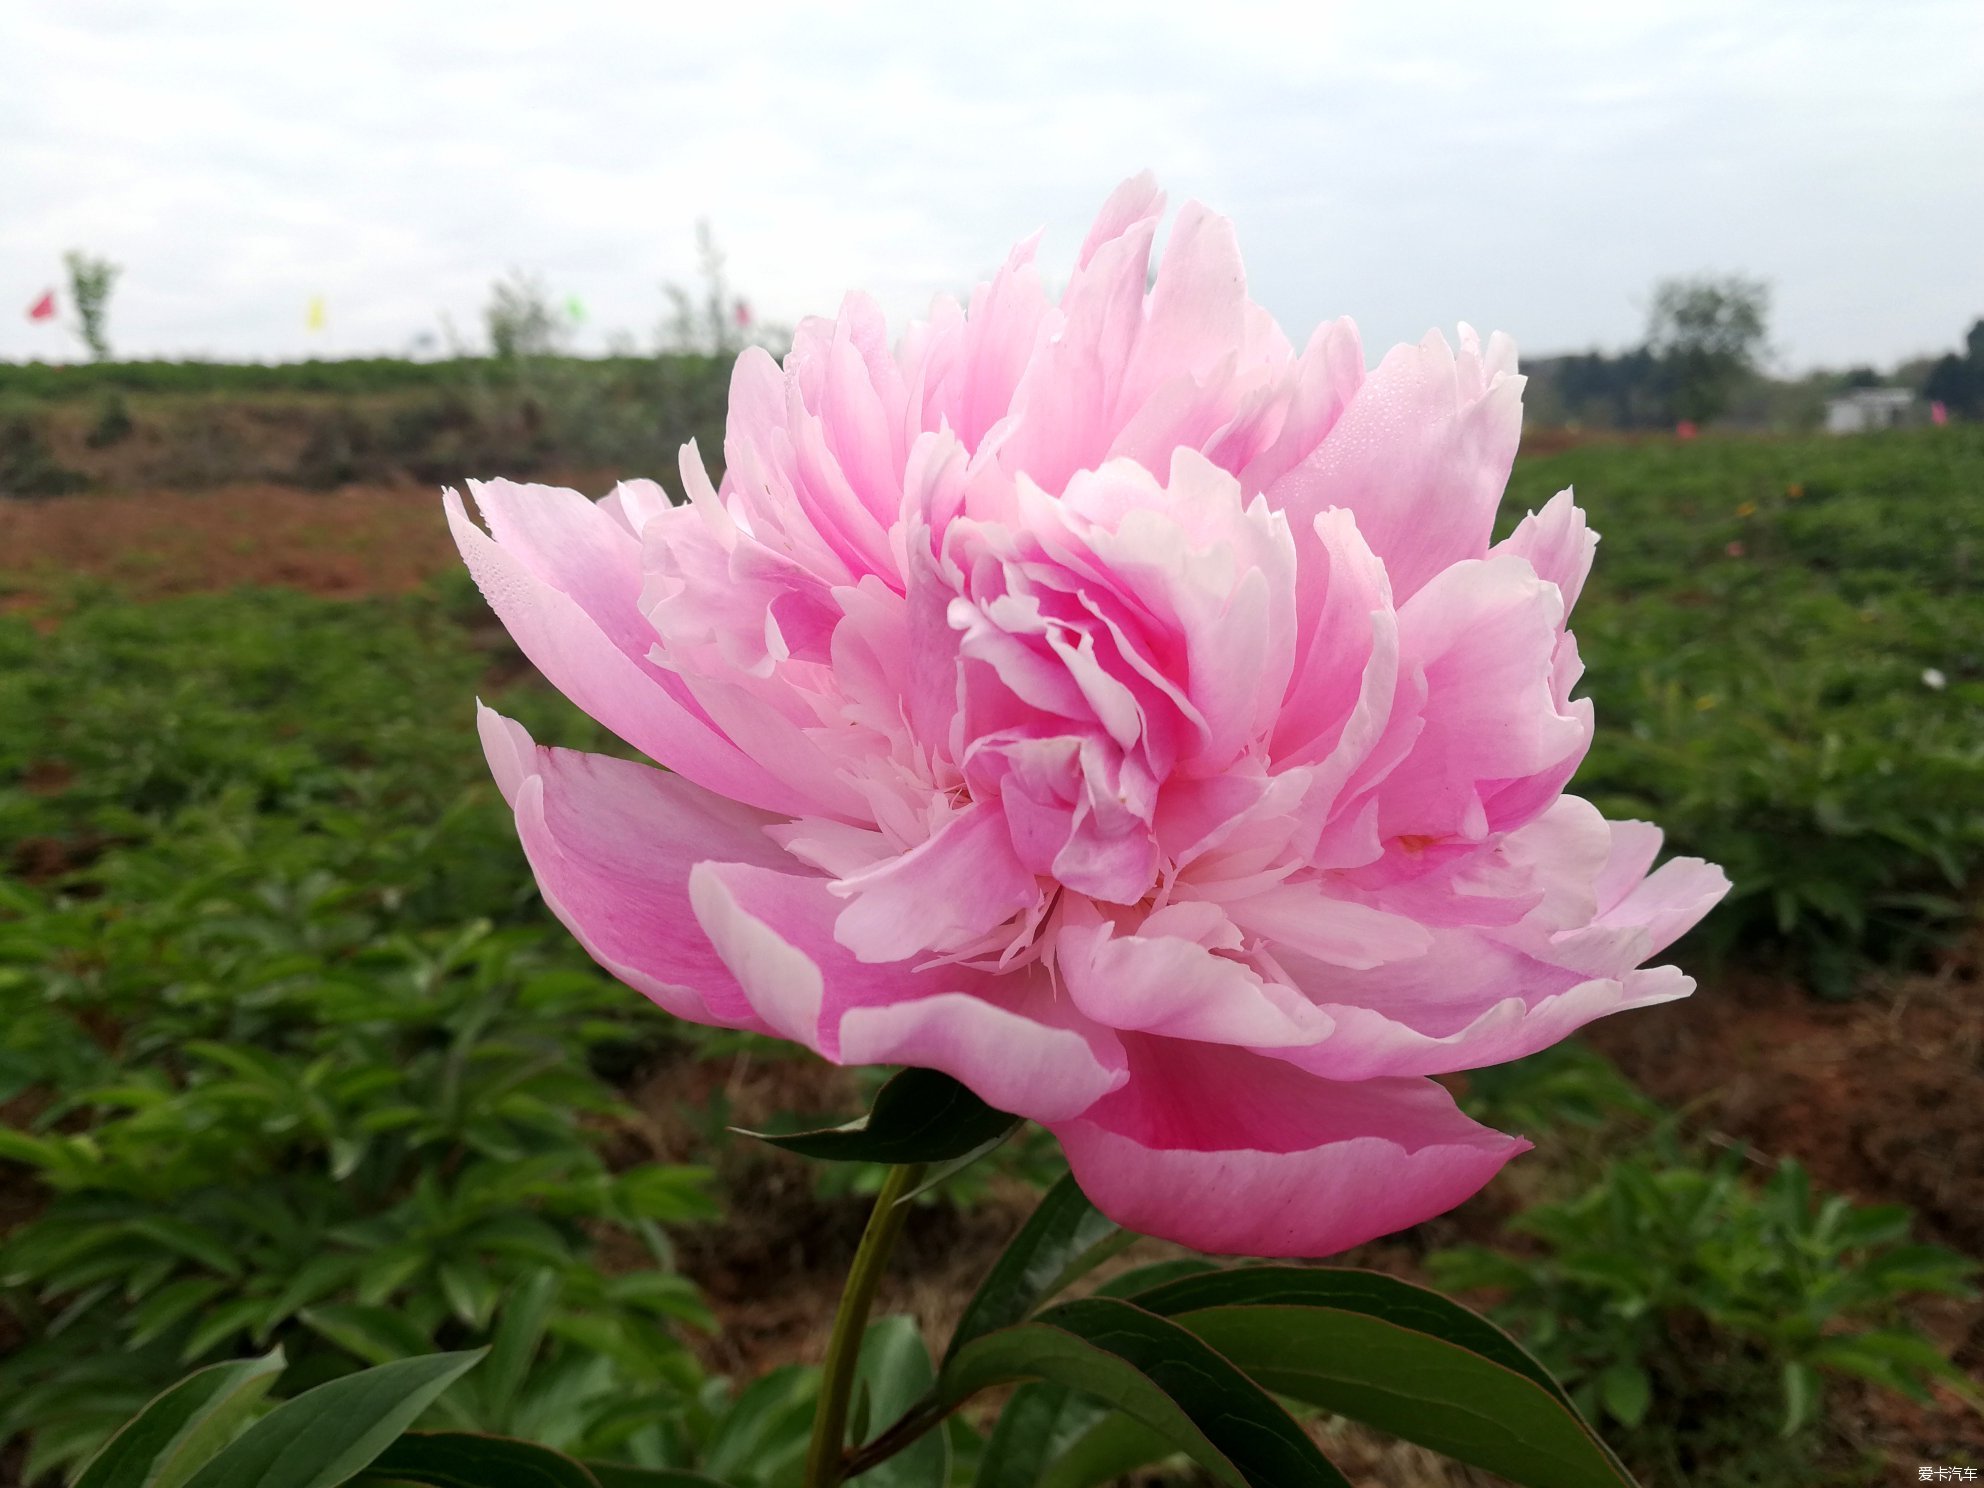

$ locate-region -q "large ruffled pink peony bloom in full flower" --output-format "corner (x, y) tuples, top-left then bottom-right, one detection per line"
(448, 177), (1728, 1256)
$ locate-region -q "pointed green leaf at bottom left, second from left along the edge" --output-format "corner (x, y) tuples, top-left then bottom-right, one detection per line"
(186, 1349), (488, 1488)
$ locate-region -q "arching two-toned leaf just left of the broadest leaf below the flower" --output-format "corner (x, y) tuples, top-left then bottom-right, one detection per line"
(938, 1298), (1349, 1488)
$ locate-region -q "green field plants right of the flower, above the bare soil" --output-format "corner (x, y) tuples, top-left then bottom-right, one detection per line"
(1508, 429), (1984, 996)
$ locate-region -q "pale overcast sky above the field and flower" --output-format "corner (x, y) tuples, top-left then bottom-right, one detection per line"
(0, 0), (1984, 369)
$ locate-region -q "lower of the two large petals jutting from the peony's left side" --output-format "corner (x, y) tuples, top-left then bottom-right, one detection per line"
(478, 708), (790, 1030)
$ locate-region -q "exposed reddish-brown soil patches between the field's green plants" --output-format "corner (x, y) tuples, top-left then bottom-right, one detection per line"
(0, 490), (1984, 1488)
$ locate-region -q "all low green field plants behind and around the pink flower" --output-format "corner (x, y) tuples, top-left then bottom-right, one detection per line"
(0, 422), (1984, 1488)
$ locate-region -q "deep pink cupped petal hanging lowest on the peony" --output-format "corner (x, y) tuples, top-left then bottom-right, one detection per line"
(1048, 1036), (1528, 1256)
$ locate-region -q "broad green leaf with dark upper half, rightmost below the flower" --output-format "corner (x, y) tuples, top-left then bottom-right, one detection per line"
(1137, 1266), (1633, 1488)
